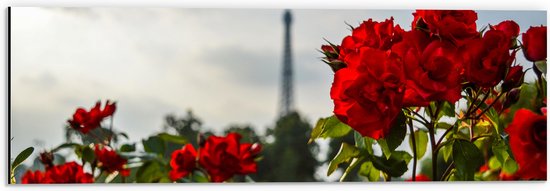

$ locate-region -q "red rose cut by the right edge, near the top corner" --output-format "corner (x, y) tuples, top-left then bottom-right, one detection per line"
(521, 26), (546, 62)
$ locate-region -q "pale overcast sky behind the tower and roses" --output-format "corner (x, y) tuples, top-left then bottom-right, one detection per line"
(11, 7), (546, 174)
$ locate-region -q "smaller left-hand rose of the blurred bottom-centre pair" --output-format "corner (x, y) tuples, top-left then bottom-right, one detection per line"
(170, 144), (201, 181)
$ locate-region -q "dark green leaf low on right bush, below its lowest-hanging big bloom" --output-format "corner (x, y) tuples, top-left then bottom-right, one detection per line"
(372, 151), (412, 177)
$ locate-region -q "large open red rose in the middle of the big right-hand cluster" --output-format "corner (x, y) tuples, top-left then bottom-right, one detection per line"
(392, 30), (461, 106)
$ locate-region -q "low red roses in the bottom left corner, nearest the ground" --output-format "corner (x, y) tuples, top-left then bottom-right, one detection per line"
(21, 146), (130, 184)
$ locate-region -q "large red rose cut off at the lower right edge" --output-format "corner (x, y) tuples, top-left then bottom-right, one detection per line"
(505, 109), (547, 180)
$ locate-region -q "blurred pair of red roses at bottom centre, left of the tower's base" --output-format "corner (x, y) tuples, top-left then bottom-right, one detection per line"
(170, 133), (261, 182)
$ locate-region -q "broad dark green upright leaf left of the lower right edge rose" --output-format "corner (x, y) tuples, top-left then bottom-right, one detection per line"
(453, 139), (484, 180)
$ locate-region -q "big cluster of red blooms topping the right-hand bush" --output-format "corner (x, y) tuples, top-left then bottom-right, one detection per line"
(321, 10), (546, 139)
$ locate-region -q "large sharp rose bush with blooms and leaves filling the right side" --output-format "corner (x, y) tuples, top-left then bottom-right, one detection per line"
(311, 10), (546, 181)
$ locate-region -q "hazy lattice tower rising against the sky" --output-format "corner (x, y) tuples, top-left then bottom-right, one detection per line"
(279, 10), (294, 116)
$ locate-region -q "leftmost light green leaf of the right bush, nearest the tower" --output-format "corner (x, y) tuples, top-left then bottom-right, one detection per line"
(309, 115), (351, 143)
